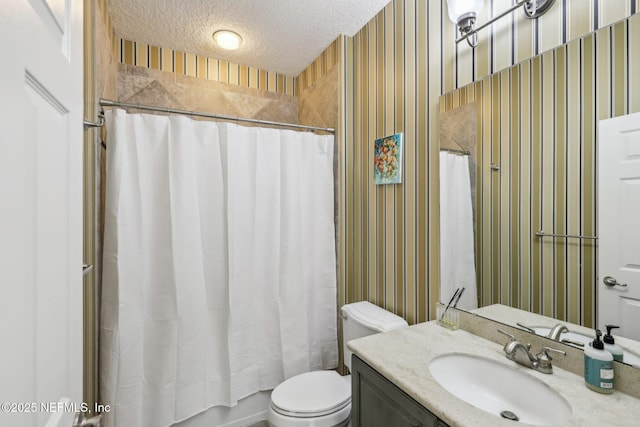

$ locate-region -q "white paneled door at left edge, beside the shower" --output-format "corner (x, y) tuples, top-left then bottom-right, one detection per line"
(0, 0), (83, 427)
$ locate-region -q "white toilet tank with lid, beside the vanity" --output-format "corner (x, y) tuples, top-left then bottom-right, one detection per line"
(341, 301), (408, 370)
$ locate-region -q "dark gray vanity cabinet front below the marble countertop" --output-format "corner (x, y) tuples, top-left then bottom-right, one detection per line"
(351, 354), (446, 427)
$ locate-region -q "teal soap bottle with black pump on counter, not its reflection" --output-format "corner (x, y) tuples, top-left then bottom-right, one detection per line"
(584, 329), (613, 394)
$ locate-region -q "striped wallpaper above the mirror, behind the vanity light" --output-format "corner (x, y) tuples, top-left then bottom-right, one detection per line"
(442, 0), (640, 93)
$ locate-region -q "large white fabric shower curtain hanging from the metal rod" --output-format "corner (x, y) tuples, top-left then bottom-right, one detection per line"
(101, 110), (338, 427)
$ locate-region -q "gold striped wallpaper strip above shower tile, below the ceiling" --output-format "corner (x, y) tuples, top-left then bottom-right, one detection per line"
(116, 38), (295, 95)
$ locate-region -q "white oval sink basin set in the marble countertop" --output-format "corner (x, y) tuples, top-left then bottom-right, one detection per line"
(429, 353), (572, 425)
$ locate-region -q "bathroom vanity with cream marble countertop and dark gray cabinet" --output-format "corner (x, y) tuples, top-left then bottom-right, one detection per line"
(348, 321), (640, 427)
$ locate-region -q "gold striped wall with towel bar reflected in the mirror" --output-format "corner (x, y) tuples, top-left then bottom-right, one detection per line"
(441, 15), (640, 326)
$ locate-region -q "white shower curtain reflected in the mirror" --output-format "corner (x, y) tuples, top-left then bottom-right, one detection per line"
(440, 151), (478, 310)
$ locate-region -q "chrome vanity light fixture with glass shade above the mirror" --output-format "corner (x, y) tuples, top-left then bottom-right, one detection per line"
(447, 0), (555, 47)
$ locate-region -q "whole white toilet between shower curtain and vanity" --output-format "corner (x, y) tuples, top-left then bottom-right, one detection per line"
(268, 301), (407, 427)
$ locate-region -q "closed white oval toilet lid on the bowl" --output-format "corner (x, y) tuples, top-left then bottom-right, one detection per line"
(271, 371), (351, 417)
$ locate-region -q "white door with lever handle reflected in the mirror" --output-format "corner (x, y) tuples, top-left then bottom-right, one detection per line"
(598, 113), (640, 340)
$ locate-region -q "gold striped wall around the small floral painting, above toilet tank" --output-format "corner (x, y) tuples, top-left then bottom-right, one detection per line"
(339, 0), (442, 323)
